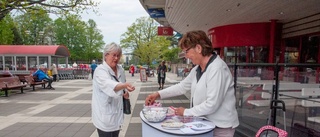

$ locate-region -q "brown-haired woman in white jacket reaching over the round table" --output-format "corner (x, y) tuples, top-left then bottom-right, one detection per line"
(145, 31), (239, 137)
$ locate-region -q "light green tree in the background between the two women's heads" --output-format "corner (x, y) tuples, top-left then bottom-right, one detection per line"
(120, 17), (170, 65)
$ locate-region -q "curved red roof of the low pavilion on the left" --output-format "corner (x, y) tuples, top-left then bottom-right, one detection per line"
(0, 45), (70, 57)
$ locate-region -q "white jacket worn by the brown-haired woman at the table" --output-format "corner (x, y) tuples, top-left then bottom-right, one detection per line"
(159, 56), (239, 128)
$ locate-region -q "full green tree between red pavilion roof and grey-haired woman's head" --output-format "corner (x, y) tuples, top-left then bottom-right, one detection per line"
(54, 15), (105, 62)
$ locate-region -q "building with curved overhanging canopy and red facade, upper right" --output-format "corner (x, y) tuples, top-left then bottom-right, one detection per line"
(140, 0), (320, 63)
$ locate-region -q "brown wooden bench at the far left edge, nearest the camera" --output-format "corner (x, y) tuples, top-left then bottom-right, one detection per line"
(0, 77), (27, 97)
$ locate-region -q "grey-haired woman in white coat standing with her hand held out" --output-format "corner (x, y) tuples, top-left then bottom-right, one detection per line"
(91, 43), (135, 137)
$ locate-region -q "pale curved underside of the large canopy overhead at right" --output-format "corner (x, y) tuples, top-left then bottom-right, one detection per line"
(139, 0), (320, 34)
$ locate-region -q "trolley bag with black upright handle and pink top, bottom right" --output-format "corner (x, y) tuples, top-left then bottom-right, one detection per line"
(256, 100), (288, 137)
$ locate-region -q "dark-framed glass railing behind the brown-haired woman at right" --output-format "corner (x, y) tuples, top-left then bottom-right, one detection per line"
(228, 63), (320, 136)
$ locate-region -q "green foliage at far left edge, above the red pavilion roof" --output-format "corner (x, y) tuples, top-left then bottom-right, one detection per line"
(0, 15), (14, 44)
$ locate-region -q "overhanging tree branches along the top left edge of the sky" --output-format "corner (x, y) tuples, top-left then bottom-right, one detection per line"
(0, 0), (99, 20)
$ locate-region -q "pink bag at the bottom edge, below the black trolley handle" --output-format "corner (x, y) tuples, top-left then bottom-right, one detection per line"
(256, 125), (288, 137)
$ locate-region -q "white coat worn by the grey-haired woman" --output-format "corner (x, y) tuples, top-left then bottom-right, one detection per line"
(91, 62), (126, 132)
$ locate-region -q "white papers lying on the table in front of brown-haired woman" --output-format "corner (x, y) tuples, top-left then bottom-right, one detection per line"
(180, 121), (214, 133)
